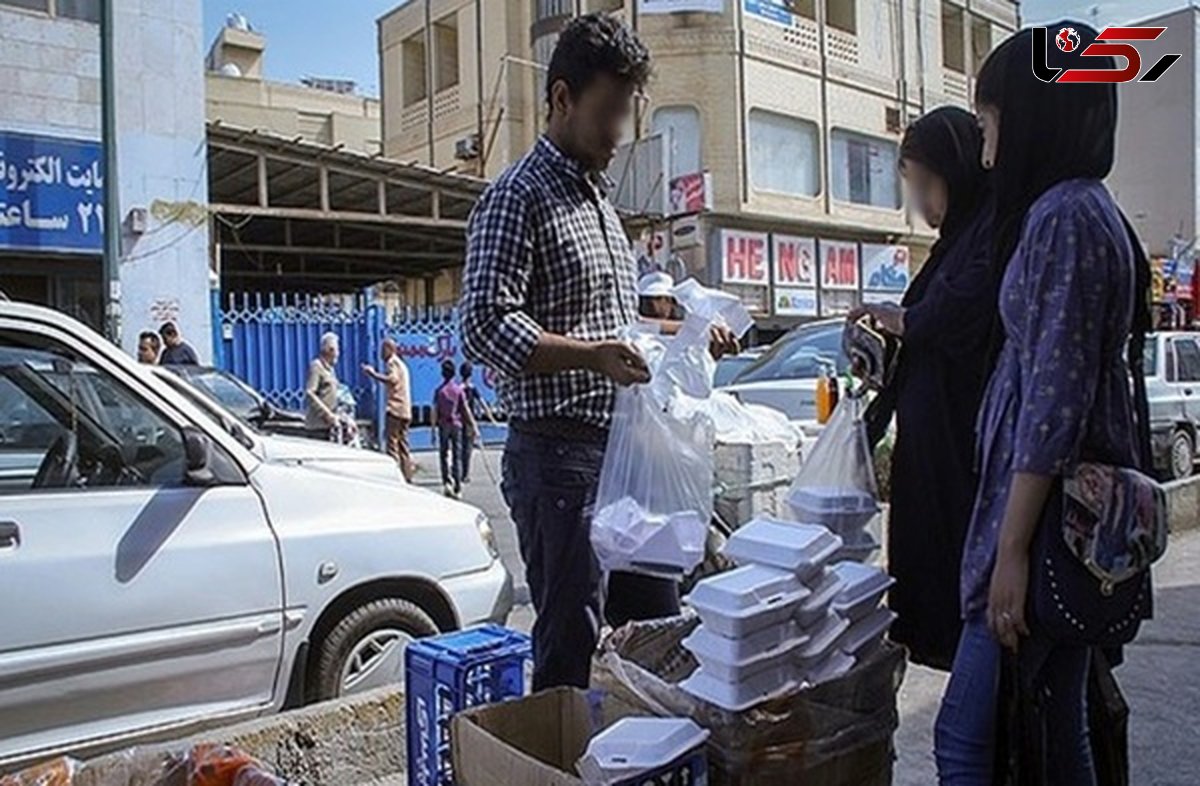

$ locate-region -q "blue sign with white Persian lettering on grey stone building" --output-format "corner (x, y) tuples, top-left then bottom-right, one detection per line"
(0, 131), (104, 253)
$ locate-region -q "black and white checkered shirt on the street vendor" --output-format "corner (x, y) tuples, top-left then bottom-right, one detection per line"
(462, 137), (637, 428)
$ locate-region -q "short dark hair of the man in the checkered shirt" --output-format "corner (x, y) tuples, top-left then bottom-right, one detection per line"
(546, 13), (650, 110)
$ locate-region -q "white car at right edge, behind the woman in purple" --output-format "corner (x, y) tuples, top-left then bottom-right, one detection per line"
(1145, 332), (1200, 480)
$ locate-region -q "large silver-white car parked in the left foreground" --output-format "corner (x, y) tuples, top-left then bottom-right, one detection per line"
(0, 302), (512, 772)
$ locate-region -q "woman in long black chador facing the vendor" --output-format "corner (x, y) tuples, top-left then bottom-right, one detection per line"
(851, 107), (996, 671)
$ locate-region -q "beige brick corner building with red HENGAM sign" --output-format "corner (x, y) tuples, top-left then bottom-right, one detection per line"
(379, 0), (1018, 328)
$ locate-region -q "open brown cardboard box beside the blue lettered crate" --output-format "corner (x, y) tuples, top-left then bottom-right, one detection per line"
(450, 688), (646, 786)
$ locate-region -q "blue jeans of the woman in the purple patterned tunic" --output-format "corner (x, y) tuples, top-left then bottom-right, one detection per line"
(934, 616), (1096, 786)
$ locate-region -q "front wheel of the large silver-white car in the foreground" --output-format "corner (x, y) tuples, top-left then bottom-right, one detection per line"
(308, 598), (440, 701)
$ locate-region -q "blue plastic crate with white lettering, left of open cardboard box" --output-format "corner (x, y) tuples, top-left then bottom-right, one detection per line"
(404, 625), (533, 786)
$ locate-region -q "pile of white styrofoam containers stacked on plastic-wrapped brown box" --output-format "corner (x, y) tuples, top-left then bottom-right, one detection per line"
(682, 517), (854, 712)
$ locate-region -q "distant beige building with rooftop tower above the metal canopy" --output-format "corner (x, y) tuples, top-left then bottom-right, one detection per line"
(205, 14), (383, 155)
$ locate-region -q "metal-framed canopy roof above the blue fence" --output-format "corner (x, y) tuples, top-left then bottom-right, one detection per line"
(208, 121), (487, 292)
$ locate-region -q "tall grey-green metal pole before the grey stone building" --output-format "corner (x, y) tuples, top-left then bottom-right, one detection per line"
(100, 0), (121, 346)
